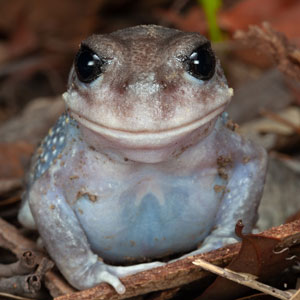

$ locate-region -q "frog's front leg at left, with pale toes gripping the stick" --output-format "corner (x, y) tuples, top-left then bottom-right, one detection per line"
(29, 178), (163, 294)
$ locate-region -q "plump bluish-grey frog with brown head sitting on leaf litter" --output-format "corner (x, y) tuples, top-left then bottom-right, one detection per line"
(18, 25), (267, 294)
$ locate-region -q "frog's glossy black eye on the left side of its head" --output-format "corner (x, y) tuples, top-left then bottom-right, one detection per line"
(74, 45), (104, 83)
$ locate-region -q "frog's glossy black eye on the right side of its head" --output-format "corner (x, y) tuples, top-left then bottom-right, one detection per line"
(187, 42), (216, 80)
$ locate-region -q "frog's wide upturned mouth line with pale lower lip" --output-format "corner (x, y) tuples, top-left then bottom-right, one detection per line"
(70, 105), (225, 145)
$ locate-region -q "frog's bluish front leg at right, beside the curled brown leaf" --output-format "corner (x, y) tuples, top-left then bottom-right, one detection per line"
(184, 142), (267, 257)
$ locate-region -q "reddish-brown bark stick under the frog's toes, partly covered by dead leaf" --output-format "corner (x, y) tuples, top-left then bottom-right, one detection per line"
(56, 220), (300, 300)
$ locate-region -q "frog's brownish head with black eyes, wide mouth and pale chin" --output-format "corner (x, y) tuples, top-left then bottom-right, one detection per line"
(64, 25), (232, 162)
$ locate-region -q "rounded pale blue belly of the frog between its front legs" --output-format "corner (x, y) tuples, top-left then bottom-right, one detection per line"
(74, 176), (220, 263)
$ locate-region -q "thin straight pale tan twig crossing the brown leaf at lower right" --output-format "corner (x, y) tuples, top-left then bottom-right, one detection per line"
(193, 258), (293, 300)
